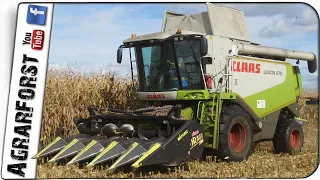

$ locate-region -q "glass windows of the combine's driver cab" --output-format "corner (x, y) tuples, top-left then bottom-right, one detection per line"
(135, 37), (204, 92)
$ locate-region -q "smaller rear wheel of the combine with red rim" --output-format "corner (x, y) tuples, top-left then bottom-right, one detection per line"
(272, 120), (304, 154)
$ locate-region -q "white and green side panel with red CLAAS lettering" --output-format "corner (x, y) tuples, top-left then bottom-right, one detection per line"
(231, 58), (296, 118)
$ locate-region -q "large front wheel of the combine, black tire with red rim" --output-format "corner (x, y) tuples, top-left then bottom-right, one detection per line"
(216, 105), (253, 161)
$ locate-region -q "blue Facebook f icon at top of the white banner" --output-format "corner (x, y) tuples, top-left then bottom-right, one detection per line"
(27, 5), (47, 25)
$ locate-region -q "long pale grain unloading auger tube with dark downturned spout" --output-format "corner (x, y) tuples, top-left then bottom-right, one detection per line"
(237, 43), (317, 73)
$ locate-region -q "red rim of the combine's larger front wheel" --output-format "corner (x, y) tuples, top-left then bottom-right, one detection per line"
(229, 123), (246, 152)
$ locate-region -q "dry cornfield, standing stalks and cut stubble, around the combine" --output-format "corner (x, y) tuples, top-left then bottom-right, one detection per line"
(37, 70), (318, 178)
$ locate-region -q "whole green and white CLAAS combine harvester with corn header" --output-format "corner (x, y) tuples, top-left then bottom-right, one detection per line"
(34, 3), (317, 169)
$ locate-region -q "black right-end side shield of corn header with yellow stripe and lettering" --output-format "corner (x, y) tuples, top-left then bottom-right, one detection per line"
(132, 120), (204, 168)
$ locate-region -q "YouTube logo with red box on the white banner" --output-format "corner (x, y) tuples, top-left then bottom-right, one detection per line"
(22, 29), (44, 50)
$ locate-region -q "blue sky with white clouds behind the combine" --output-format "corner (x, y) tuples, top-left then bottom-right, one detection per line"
(49, 3), (319, 89)
